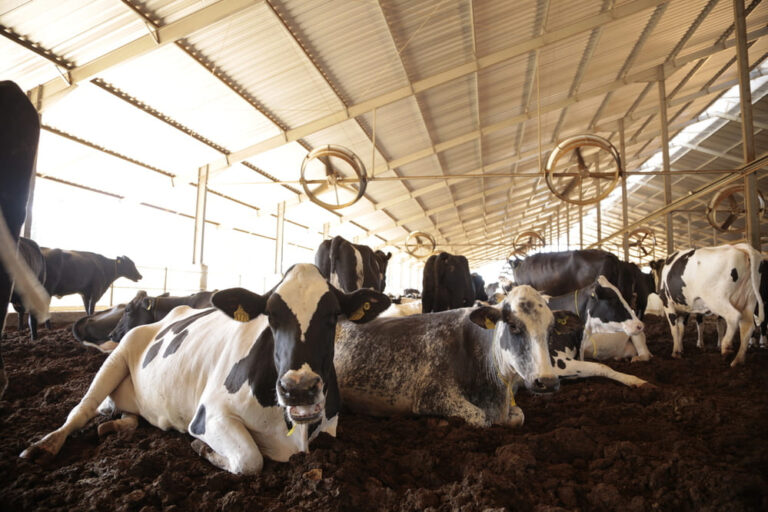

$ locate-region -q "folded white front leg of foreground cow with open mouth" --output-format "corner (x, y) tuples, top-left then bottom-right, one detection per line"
(192, 416), (264, 475)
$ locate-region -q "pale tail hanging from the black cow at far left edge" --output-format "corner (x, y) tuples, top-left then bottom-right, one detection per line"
(0, 211), (51, 322)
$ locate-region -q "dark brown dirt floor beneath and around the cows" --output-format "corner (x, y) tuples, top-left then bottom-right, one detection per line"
(0, 317), (768, 512)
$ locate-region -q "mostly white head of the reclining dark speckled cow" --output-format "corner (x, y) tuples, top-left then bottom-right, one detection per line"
(469, 285), (560, 393)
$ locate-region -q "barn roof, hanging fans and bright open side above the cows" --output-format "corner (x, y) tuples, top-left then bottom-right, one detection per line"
(0, 0), (768, 307)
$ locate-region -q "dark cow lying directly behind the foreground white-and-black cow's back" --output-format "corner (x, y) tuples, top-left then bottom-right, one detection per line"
(109, 290), (215, 343)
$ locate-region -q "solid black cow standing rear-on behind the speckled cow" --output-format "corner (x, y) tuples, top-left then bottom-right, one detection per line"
(421, 252), (475, 313)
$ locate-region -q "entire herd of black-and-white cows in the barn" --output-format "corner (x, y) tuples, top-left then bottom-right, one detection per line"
(0, 82), (768, 474)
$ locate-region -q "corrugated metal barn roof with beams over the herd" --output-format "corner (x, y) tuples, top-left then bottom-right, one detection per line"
(0, 0), (768, 272)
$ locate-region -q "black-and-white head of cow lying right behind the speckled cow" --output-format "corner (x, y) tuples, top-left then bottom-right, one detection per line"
(577, 275), (644, 336)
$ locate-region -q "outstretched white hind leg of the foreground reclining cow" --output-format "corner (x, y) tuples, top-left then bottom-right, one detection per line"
(20, 350), (129, 460)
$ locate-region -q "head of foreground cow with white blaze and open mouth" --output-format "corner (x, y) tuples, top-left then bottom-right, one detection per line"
(211, 264), (390, 423)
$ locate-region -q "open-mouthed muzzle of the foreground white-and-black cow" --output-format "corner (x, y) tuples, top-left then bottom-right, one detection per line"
(277, 370), (325, 423)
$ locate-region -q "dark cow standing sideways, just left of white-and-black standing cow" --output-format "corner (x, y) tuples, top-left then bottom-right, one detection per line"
(510, 249), (653, 320)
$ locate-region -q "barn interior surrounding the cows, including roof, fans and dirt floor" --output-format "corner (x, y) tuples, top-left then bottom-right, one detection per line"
(0, 0), (768, 512)
